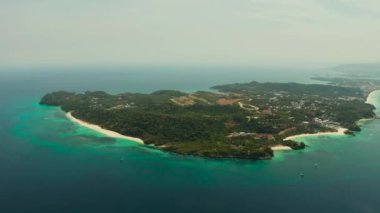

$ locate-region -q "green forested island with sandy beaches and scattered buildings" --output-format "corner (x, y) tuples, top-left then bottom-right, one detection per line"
(40, 78), (378, 159)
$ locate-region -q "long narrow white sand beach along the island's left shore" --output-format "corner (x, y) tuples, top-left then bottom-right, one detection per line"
(66, 112), (144, 144)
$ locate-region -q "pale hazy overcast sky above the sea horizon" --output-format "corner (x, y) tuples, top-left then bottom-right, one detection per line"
(0, 0), (380, 66)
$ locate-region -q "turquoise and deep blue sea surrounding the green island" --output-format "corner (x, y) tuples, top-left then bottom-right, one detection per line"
(0, 67), (380, 213)
